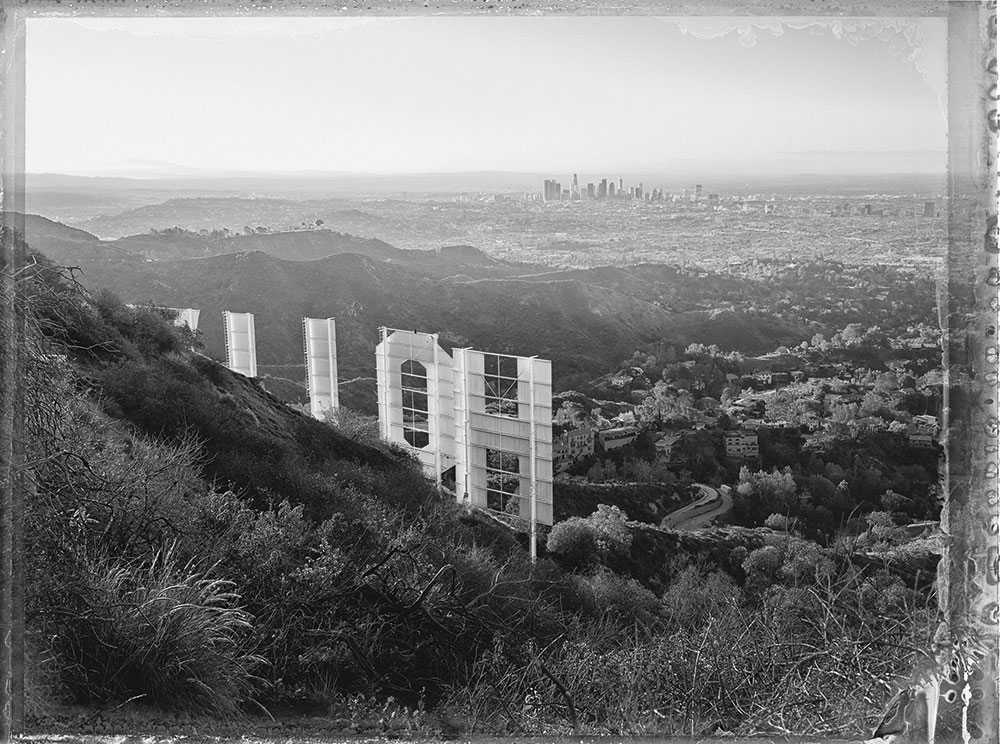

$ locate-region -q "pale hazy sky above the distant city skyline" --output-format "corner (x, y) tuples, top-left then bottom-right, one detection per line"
(26, 16), (947, 174)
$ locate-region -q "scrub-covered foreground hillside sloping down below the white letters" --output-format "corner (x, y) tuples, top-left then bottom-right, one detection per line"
(17, 248), (932, 736)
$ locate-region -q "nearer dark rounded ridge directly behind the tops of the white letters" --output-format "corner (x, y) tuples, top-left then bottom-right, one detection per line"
(47, 251), (670, 392)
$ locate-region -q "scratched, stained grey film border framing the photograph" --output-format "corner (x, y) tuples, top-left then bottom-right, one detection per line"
(0, 0), (1000, 744)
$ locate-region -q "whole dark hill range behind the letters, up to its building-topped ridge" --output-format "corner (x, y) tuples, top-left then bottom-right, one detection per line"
(28, 218), (807, 405)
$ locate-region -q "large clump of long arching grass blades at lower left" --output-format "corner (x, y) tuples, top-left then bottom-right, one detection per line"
(56, 551), (262, 716)
